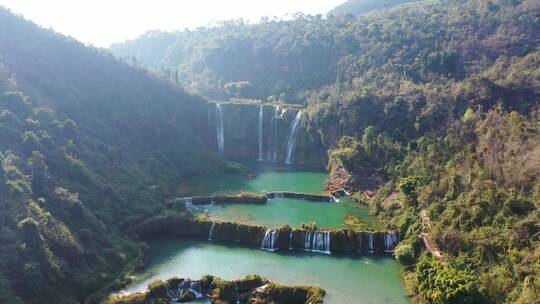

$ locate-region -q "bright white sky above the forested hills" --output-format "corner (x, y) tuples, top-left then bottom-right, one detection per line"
(0, 0), (344, 47)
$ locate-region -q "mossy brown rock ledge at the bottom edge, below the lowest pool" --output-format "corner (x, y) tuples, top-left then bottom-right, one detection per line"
(105, 275), (325, 304)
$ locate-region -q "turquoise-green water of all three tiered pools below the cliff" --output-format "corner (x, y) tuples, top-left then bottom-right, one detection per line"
(124, 165), (409, 304)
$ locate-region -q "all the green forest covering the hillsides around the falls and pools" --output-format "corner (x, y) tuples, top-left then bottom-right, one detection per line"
(0, 0), (540, 304)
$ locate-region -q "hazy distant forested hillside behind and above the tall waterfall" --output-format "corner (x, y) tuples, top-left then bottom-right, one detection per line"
(111, 0), (539, 103)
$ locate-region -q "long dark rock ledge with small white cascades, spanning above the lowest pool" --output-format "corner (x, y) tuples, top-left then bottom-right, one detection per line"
(132, 216), (399, 254)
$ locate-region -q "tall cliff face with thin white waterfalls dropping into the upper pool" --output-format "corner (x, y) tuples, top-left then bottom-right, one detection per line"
(207, 102), (327, 167)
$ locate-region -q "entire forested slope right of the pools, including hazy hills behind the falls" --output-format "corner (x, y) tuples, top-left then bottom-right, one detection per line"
(112, 0), (540, 303)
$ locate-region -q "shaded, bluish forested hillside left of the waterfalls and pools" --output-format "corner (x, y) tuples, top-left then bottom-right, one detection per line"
(0, 8), (232, 303)
